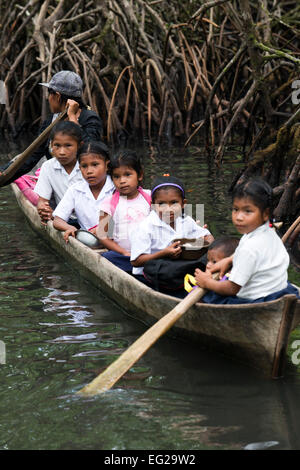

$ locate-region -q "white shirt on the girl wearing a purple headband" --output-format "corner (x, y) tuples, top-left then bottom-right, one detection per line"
(130, 210), (211, 274)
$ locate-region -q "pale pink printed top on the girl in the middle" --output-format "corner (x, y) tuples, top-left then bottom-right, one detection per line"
(101, 189), (151, 251)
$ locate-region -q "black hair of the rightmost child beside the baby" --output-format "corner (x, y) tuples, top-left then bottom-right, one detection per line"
(232, 178), (273, 219)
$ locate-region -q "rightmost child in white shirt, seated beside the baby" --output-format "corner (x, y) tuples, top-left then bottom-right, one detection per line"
(195, 179), (298, 304)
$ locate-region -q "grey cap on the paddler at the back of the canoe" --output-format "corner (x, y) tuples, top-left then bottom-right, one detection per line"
(39, 70), (83, 97)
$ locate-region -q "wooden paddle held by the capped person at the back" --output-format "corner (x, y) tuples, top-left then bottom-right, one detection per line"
(0, 108), (68, 188)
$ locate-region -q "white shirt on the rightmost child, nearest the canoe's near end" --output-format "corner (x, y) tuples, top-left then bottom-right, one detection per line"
(229, 222), (289, 300)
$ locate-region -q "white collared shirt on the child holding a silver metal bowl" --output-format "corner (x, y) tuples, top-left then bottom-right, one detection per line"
(53, 176), (115, 230)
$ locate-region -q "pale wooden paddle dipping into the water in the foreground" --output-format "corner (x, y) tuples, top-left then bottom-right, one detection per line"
(77, 273), (214, 395)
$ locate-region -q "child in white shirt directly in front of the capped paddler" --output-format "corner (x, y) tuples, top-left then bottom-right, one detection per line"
(34, 121), (83, 224)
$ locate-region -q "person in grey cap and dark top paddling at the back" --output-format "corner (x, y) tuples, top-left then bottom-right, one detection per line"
(0, 70), (102, 184)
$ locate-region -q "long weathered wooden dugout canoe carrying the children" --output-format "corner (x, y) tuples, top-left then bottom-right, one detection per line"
(12, 184), (300, 378)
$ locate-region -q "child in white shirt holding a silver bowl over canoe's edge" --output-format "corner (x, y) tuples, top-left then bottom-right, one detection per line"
(53, 142), (115, 242)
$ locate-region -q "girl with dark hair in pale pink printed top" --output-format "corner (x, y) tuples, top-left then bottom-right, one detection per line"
(96, 150), (151, 273)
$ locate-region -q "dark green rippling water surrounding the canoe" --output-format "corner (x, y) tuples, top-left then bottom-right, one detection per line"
(0, 141), (300, 451)
